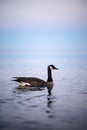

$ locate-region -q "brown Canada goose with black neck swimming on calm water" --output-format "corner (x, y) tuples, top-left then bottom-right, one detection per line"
(13, 65), (58, 88)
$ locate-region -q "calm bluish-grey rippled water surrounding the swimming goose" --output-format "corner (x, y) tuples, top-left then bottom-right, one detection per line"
(0, 51), (87, 130)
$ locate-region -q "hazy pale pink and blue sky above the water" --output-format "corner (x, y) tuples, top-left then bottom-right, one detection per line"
(0, 0), (87, 53)
